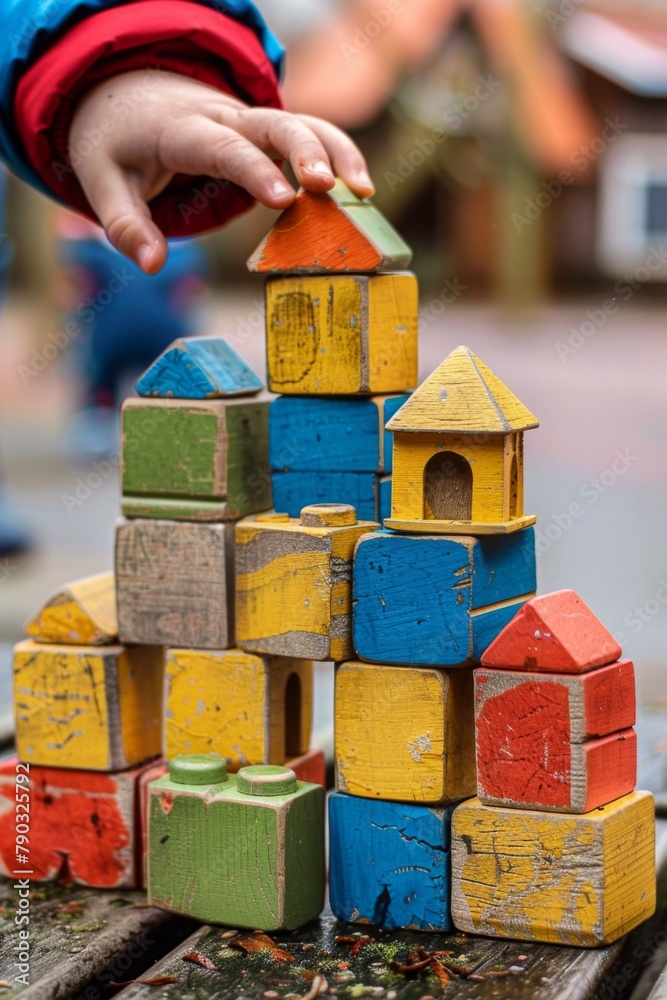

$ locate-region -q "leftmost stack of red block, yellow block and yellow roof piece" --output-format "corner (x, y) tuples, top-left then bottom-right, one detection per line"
(0, 573), (163, 888)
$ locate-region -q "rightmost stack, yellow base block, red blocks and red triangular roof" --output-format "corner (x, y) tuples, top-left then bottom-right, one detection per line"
(452, 590), (656, 946)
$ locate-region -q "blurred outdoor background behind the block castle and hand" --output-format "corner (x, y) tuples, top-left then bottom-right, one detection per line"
(0, 0), (667, 749)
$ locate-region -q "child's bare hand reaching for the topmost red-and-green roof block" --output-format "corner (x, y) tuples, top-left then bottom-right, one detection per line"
(69, 70), (373, 274)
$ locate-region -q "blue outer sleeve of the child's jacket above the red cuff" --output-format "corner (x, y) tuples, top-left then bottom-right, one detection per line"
(0, 0), (283, 194)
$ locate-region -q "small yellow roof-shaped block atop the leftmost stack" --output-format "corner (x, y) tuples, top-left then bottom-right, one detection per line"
(24, 573), (118, 646)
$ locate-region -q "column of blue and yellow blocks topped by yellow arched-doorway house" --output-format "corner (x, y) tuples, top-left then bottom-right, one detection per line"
(329, 348), (537, 931)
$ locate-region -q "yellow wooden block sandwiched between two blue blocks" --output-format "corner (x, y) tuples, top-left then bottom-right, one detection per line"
(334, 661), (476, 805)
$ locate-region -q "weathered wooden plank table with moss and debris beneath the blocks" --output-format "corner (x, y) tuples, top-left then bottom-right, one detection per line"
(0, 710), (667, 1000)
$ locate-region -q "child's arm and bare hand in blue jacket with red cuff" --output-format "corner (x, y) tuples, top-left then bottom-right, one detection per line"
(0, 0), (372, 271)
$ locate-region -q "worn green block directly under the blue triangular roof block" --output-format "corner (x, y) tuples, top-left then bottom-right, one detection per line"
(121, 399), (271, 521)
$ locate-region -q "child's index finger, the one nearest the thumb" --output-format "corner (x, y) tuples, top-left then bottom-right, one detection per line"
(159, 115), (296, 208)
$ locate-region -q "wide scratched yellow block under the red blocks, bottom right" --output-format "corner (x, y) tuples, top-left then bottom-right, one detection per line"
(452, 792), (656, 947)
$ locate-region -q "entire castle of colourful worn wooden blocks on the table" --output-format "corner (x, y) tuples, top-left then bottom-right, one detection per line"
(0, 182), (655, 946)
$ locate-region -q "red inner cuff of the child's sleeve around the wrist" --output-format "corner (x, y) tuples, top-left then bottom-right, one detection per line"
(14, 0), (282, 236)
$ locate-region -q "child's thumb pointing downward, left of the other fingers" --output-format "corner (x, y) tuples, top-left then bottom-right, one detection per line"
(78, 158), (167, 274)
